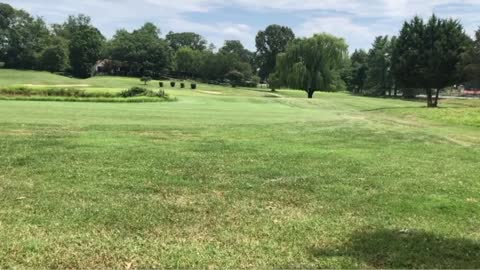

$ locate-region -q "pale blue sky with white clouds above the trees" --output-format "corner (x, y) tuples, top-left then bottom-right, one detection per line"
(0, 0), (480, 50)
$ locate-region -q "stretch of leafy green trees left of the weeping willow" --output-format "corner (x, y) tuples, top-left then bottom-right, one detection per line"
(0, 3), (286, 86)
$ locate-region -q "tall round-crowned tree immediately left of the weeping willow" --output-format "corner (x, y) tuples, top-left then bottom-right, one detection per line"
(255, 24), (295, 80)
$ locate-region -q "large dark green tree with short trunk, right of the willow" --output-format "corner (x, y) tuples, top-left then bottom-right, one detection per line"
(393, 15), (470, 107)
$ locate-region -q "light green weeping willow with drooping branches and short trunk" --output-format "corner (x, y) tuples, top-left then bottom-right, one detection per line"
(275, 34), (348, 98)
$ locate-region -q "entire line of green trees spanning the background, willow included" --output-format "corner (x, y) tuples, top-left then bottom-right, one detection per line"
(0, 3), (480, 107)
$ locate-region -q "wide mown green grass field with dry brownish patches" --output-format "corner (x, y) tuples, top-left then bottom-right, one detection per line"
(0, 70), (480, 269)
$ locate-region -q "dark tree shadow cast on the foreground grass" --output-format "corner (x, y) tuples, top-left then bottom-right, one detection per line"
(310, 230), (480, 269)
